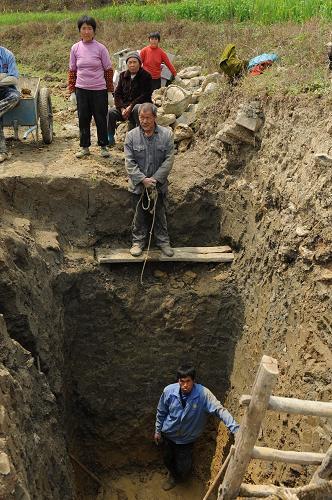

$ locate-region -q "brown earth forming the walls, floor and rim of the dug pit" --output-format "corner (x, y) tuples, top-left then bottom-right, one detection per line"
(0, 75), (332, 500)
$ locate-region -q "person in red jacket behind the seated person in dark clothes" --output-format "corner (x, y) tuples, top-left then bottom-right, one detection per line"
(140, 32), (179, 90)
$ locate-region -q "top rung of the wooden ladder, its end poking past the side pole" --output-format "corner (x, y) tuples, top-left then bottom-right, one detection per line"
(240, 394), (332, 418)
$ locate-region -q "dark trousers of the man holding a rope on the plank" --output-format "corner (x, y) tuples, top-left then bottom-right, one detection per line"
(132, 192), (169, 248)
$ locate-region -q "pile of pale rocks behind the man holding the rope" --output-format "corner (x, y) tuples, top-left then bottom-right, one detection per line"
(152, 66), (221, 152)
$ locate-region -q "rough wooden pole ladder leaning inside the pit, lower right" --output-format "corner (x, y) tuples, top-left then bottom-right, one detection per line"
(209, 356), (332, 500)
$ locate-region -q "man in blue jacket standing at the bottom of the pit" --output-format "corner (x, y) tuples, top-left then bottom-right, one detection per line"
(154, 364), (240, 491)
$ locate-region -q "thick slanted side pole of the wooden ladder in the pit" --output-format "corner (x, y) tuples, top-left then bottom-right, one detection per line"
(218, 356), (279, 500)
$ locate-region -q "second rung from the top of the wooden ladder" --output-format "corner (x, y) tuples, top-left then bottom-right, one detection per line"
(251, 446), (325, 465)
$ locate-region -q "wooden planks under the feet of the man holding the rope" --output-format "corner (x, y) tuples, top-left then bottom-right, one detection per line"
(96, 248), (234, 264)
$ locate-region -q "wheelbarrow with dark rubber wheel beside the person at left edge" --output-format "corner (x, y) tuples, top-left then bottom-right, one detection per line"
(3, 76), (53, 144)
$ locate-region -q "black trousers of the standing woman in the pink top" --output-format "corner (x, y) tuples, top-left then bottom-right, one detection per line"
(76, 87), (108, 148)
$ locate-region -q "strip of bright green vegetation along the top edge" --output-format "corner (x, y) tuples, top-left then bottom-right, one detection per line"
(0, 0), (332, 25)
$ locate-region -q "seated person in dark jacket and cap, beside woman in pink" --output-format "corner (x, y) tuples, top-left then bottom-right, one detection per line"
(108, 52), (152, 146)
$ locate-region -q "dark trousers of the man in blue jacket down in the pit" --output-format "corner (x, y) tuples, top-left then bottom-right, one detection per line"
(163, 436), (194, 482)
